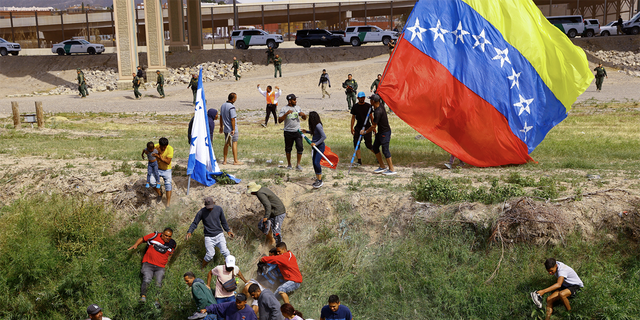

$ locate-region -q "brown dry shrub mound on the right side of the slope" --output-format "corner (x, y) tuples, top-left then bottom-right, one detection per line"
(490, 197), (571, 243)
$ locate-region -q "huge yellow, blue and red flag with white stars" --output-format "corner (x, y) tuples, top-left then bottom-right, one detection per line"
(378, 0), (593, 167)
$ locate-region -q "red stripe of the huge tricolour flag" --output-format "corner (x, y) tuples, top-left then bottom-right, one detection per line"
(378, 38), (533, 167)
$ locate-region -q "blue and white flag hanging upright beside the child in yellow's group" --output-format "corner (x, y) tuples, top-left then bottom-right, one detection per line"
(187, 68), (240, 187)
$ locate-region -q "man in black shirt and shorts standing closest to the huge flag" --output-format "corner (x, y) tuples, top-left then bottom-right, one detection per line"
(360, 94), (397, 175)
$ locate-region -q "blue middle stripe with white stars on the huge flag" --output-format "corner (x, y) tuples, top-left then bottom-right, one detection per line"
(404, 0), (567, 153)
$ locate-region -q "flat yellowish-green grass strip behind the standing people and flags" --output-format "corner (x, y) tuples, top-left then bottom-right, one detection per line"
(0, 103), (640, 173)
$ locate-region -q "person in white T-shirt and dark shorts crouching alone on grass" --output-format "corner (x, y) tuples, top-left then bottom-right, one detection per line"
(531, 258), (584, 320)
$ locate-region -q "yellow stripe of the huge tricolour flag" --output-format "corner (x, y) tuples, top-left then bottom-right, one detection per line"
(462, 0), (593, 111)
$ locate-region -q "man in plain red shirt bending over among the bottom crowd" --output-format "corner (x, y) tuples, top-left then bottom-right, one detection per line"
(260, 242), (302, 303)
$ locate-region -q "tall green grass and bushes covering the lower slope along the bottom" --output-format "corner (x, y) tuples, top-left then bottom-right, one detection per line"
(0, 195), (640, 319)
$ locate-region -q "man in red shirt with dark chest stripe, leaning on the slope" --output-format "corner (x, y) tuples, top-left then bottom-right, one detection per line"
(127, 228), (176, 302)
